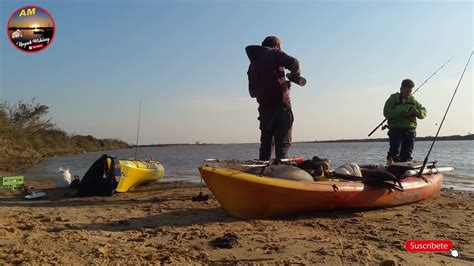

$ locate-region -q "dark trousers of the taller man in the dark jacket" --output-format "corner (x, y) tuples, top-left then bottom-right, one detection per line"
(258, 106), (294, 161)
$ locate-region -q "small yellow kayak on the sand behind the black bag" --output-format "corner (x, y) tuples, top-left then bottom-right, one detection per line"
(115, 160), (165, 192)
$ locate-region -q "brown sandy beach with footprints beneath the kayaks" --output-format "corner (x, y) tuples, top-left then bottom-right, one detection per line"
(0, 180), (474, 265)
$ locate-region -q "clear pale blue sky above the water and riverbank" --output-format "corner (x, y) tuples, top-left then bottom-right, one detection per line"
(0, 1), (474, 143)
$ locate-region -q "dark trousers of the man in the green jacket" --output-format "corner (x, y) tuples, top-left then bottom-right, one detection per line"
(387, 128), (416, 162)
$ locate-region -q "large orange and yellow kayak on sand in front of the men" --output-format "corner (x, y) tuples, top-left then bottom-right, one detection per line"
(199, 165), (443, 218)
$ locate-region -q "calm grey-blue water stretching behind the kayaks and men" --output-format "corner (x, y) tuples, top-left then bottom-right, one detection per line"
(25, 141), (474, 190)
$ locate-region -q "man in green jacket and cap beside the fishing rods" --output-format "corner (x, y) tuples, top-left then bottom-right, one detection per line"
(383, 79), (426, 164)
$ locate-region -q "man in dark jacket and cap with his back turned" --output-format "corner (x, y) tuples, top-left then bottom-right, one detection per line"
(245, 36), (300, 161)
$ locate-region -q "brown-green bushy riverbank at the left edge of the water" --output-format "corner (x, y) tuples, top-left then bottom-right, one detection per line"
(0, 99), (129, 172)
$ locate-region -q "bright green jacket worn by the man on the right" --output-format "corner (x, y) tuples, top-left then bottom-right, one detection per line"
(383, 92), (426, 128)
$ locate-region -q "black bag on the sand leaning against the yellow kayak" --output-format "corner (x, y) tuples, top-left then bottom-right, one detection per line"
(77, 154), (120, 196)
